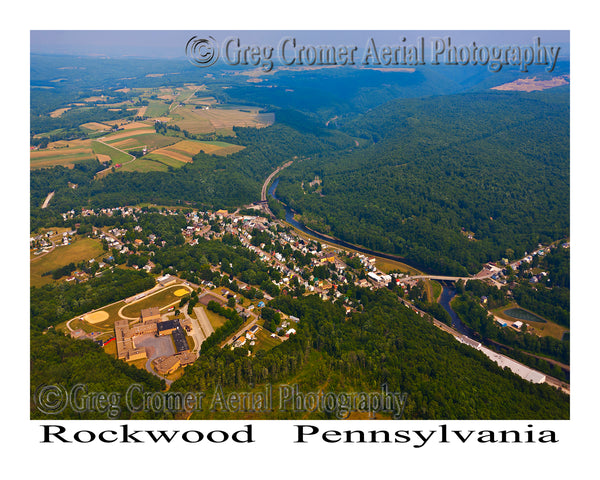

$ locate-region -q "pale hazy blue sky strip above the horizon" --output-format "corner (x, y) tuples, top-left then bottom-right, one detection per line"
(30, 30), (570, 58)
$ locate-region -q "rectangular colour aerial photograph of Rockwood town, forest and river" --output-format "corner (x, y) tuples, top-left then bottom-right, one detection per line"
(29, 30), (571, 424)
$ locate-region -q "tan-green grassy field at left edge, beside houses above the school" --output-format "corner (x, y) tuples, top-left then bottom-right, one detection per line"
(29, 238), (104, 287)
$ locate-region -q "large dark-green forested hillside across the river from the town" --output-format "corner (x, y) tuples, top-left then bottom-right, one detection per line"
(277, 89), (569, 275)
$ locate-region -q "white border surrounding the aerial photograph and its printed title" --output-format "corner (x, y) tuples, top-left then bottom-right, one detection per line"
(2, 0), (598, 479)
